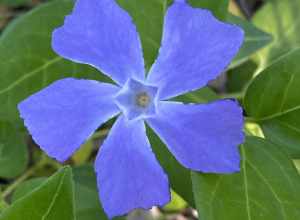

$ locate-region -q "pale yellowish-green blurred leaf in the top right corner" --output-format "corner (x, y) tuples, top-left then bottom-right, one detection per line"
(253, 0), (300, 68)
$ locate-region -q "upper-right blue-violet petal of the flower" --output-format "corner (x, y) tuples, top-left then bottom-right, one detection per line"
(148, 1), (244, 99)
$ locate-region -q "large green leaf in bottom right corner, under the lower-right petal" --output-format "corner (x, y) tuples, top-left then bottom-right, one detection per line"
(192, 137), (300, 220)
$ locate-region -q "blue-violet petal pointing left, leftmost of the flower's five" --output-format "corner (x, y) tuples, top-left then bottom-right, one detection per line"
(18, 78), (119, 162)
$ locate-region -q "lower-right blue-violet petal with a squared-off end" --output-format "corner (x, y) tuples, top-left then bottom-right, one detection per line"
(147, 100), (244, 173)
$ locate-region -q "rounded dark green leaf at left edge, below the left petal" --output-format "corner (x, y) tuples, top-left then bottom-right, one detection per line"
(0, 121), (28, 178)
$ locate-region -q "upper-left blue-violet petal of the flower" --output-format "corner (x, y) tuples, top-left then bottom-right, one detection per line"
(52, 0), (145, 85)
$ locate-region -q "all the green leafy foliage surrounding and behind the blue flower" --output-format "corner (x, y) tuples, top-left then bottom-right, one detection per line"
(0, 0), (300, 220)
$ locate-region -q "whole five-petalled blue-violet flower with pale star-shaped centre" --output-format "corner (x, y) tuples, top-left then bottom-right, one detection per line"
(19, 0), (244, 218)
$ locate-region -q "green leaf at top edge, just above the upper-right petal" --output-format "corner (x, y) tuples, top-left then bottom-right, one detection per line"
(189, 0), (229, 20)
